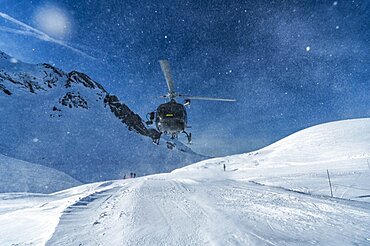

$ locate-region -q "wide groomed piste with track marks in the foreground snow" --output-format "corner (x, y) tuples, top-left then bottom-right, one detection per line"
(36, 177), (370, 245)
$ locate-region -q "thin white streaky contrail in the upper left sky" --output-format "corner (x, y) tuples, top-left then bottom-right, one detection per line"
(0, 12), (96, 60)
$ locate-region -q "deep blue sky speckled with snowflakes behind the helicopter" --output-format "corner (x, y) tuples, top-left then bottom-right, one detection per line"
(0, 0), (370, 155)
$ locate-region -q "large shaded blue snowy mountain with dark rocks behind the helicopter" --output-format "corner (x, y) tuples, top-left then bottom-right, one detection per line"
(0, 53), (205, 182)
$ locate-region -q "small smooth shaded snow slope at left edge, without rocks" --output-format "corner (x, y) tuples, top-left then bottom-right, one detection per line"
(0, 154), (81, 193)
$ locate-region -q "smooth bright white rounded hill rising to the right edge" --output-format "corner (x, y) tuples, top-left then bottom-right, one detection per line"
(176, 118), (370, 171)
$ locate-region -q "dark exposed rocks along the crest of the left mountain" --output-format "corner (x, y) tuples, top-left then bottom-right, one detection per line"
(0, 52), (159, 141)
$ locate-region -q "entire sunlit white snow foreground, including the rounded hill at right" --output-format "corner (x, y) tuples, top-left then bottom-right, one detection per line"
(0, 119), (370, 245)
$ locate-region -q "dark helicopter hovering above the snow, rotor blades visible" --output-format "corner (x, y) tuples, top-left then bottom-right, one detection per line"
(146, 60), (236, 144)
